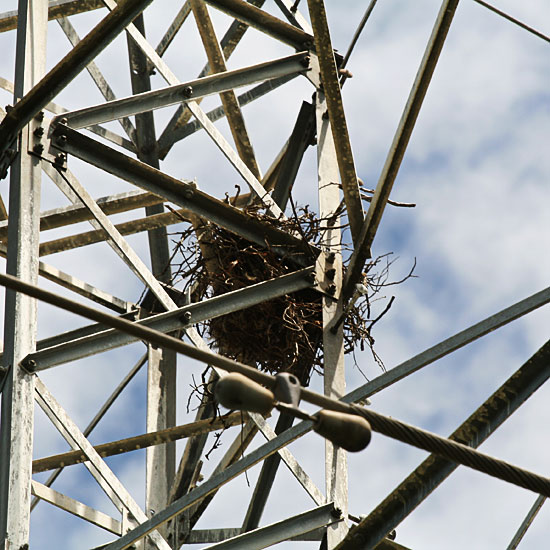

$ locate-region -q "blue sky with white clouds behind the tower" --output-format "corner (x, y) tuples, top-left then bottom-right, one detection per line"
(0, 0), (550, 550)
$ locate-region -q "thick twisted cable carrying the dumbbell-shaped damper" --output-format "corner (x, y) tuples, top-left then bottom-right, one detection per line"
(0, 274), (550, 497)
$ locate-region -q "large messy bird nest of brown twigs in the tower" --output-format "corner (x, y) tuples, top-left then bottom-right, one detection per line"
(164, 207), (410, 385)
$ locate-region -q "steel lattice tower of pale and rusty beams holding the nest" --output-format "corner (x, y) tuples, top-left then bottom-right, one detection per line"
(0, 0), (550, 550)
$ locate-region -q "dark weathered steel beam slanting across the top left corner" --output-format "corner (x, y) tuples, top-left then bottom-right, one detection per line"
(0, 0), (152, 178)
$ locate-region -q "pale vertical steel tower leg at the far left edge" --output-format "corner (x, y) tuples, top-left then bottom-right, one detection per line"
(0, 0), (48, 549)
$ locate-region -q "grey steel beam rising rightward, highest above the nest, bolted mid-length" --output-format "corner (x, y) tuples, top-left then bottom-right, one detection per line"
(58, 52), (309, 129)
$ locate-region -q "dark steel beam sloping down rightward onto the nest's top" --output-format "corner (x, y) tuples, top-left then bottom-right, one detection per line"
(52, 124), (319, 266)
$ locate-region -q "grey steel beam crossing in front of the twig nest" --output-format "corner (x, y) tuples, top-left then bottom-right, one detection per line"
(16, 267), (314, 371)
